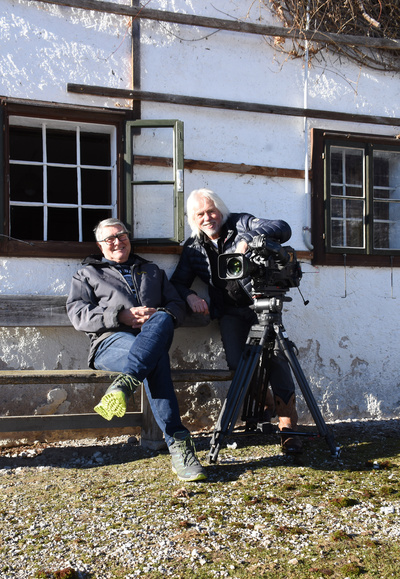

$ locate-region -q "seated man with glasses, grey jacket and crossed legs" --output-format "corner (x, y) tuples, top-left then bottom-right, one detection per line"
(67, 218), (206, 481)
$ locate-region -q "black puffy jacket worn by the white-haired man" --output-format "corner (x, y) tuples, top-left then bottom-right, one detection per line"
(171, 213), (292, 318)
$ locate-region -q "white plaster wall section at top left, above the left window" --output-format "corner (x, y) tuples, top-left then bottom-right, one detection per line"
(0, 0), (132, 107)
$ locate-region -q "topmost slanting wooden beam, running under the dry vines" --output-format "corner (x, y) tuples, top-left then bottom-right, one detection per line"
(30, 0), (400, 50)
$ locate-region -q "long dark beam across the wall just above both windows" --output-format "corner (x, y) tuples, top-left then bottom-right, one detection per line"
(67, 83), (400, 126)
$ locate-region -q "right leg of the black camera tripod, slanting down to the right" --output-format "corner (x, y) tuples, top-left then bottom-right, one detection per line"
(274, 324), (339, 456)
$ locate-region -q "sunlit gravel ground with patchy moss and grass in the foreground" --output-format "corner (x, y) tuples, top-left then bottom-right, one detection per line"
(0, 420), (400, 579)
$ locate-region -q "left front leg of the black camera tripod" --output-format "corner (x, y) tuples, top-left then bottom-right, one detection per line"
(208, 343), (263, 463)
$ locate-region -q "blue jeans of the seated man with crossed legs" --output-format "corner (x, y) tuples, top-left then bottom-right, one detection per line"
(94, 312), (188, 446)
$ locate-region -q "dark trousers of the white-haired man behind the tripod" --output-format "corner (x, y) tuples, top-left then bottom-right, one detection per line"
(219, 307), (295, 404)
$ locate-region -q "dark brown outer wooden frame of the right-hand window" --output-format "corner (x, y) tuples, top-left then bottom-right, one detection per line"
(311, 129), (400, 267)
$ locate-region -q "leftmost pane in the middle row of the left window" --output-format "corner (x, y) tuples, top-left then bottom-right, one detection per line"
(10, 165), (43, 203)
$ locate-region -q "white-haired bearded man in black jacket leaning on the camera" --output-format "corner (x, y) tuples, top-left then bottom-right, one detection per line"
(171, 189), (301, 453)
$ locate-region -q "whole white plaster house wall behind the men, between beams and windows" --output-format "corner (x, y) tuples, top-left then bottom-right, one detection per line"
(0, 0), (400, 426)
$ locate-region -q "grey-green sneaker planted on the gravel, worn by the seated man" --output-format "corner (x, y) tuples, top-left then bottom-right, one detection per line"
(169, 432), (207, 481)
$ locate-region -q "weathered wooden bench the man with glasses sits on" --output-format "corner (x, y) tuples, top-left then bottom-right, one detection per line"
(0, 295), (233, 448)
